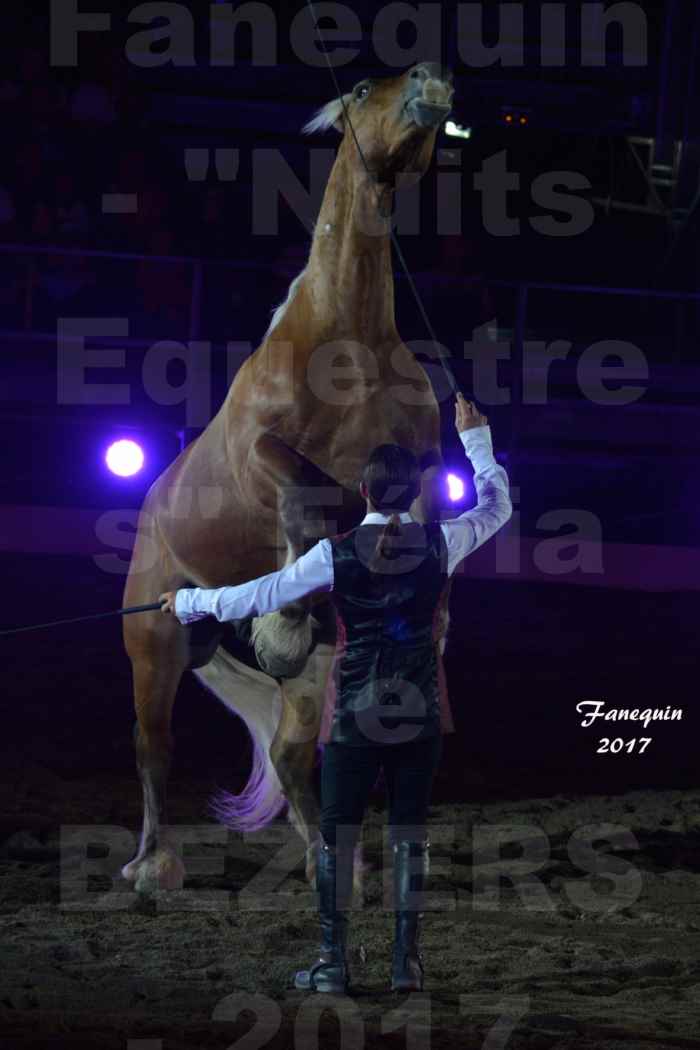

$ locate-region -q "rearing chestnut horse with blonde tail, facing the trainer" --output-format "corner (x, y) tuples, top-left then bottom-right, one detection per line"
(123, 63), (453, 889)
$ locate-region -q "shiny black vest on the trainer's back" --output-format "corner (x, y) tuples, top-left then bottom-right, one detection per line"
(328, 522), (447, 747)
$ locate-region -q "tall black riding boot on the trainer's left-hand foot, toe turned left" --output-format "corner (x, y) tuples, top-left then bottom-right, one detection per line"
(294, 836), (353, 995)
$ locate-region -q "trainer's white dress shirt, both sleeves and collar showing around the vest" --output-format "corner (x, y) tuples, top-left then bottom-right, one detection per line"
(175, 425), (513, 624)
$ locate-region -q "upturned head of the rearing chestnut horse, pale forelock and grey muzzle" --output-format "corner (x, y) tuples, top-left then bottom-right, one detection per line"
(303, 62), (454, 183)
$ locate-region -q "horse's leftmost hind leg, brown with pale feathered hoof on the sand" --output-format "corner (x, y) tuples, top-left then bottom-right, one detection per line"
(122, 638), (185, 893)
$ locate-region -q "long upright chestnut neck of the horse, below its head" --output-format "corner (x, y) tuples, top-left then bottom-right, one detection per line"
(304, 142), (396, 349)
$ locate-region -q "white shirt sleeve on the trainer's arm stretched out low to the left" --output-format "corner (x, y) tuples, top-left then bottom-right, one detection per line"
(175, 540), (333, 624)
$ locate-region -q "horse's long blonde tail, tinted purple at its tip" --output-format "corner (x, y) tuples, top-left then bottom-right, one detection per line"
(194, 648), (287, 832)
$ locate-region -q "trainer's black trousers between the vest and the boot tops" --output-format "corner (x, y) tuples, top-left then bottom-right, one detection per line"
(321, 733), (443, 845)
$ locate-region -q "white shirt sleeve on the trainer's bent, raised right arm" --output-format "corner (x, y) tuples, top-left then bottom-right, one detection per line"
(441, 425), (513, 575)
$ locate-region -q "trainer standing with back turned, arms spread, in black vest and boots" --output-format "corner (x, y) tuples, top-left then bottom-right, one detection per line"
(161, 394), (512, 993)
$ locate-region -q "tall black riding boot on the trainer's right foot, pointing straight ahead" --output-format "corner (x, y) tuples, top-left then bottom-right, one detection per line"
(391, 838), (430, 991)
